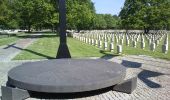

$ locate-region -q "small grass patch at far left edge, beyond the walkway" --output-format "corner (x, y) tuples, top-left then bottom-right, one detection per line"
(0, 36), (18, 46)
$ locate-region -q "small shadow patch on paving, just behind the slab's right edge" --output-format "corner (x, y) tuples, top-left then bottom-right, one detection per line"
(121, 60), (142, 68)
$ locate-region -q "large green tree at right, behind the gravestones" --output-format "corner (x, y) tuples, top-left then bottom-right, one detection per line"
(119, 0), (170, 31)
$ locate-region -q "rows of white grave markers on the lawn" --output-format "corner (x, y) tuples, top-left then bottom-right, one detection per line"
(73, 31), (168, 54)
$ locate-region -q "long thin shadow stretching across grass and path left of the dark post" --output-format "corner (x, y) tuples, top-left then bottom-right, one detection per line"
(5, 44), (55, 59)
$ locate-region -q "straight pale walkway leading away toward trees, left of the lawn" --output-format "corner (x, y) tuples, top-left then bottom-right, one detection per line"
(0, 34), (41, 62)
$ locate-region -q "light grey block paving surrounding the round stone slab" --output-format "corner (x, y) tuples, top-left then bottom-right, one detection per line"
(0, 56), (170, 100)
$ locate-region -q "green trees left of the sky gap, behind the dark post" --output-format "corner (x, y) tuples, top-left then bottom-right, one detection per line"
(0, 0), (118, 32)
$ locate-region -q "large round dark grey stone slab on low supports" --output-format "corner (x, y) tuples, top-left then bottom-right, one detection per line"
(8, 59), (126, 93)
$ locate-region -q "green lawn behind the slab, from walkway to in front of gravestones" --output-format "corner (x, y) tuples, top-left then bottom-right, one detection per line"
(14, 35), (170, 60)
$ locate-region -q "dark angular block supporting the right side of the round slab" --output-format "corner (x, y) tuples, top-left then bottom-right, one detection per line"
(113, 77), (137, 94)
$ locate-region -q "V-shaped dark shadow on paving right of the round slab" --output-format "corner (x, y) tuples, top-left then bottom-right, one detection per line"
(138, 70), (164, 88)
